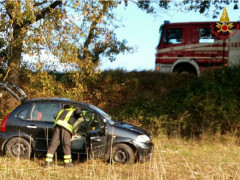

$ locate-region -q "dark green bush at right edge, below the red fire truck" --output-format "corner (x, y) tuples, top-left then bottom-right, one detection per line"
(183, 67), (240, 135)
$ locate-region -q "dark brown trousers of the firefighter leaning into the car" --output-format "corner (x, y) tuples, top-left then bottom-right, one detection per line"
(48, 125), (72, 155)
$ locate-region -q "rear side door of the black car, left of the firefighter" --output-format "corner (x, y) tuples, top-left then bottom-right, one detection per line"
(18, 102), (60, 152)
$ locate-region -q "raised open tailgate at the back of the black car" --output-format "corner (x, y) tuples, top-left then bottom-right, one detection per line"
(0, 81), (27, 103)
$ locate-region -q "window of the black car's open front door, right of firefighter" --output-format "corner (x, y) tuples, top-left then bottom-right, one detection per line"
(82, 110), (103, 131)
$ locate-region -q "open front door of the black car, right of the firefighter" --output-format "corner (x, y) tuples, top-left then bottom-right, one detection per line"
(82, 109), (107, 157)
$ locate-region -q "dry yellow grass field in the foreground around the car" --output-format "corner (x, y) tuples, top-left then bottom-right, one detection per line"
(0, 137), (240, 180)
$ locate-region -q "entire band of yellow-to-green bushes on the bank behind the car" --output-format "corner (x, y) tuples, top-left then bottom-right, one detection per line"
(3, 67), (240, 137)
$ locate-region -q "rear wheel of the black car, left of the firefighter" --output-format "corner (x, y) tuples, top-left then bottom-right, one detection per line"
(5, 137), (31, 158)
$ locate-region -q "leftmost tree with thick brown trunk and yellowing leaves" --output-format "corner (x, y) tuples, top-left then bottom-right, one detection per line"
(1, 0), (62, 83)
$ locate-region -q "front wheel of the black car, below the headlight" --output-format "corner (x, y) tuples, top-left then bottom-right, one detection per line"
(112, 144), (135, 164)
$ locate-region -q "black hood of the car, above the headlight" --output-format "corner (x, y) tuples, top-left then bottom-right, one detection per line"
(114, 122), (150, 137)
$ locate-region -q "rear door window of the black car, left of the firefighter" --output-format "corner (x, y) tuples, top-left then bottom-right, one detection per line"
(30, 102), (60, 122)
